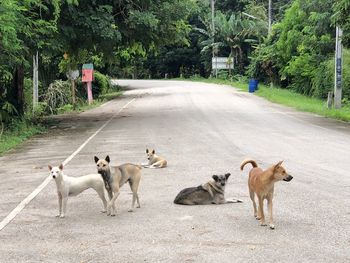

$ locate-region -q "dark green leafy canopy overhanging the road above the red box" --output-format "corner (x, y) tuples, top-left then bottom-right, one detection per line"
(58, 0), (195, 78)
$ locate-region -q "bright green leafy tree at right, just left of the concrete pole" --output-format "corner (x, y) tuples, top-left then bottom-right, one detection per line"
(249, 0), (334, 95)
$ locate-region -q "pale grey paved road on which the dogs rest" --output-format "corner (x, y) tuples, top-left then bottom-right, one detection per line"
(0, 81), (350, 262)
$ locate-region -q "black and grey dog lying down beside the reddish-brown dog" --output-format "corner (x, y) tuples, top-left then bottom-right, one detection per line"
(174, 173), (242, 205)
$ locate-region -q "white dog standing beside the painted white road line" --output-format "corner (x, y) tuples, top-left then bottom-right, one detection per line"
(48, 164), (107, 218)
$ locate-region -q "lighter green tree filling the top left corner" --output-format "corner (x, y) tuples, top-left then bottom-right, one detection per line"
(0, 0), (59, 115)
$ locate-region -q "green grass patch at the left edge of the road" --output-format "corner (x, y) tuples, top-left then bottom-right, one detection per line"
(0, 120), (46, 156)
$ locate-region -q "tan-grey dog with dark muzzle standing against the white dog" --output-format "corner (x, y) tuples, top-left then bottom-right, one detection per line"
(94, 155), (141, 216)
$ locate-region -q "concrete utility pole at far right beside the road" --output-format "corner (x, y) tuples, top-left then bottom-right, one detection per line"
(334, 26), (343, 109)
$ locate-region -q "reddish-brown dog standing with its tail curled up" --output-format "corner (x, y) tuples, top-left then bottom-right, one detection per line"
(241, 160), (293, 229)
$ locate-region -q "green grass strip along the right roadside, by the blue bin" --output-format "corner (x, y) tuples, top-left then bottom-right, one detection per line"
(183, 77), (350, 121)
